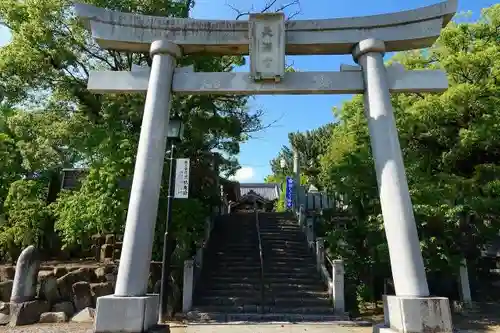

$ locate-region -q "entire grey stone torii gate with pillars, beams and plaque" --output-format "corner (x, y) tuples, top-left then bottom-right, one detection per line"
(75, 0), (457, 332)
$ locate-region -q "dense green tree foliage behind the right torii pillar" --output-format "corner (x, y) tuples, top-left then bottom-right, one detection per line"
(320, 5), (500, 306)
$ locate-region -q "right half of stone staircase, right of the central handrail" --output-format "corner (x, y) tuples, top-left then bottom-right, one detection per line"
(259, 213), (333, 315)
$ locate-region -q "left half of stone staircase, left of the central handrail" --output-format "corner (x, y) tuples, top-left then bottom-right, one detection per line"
(193, 213), (261, 314)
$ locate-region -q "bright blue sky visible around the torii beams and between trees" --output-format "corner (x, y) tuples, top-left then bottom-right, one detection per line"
(0, 0), (497, 182)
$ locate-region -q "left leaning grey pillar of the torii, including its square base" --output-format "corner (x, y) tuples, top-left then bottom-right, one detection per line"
(94, 40), (181, 332)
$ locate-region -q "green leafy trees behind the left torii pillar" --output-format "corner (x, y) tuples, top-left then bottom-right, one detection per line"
(0, 0), (262, 266)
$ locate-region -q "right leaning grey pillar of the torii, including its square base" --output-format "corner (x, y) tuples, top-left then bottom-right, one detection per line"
(353, 39), (452, 332)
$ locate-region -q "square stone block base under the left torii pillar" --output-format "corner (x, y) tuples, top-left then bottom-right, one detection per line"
(94, 294), (160, 333)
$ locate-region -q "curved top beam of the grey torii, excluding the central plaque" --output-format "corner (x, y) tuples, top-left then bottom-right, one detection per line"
(75, 0), (457, 55)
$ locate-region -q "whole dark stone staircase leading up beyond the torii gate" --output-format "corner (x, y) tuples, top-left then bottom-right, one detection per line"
(188, 212), (348, 322)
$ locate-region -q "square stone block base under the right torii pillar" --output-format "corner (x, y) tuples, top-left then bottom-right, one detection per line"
(373, 296), (453, 333)
